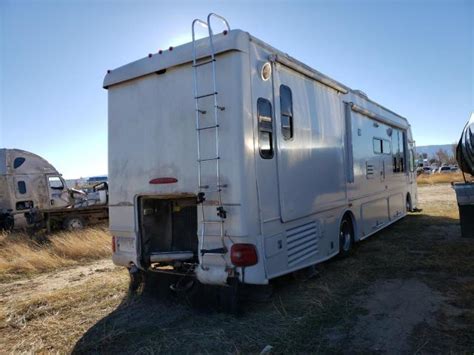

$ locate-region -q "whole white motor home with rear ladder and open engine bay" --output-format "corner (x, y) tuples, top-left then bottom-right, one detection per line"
(104, 14), (417, 304)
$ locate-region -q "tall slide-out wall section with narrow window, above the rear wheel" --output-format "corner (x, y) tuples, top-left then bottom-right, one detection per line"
(273, 63), (346, 222)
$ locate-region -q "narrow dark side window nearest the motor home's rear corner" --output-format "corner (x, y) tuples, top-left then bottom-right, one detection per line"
(257, 98), (273, 159)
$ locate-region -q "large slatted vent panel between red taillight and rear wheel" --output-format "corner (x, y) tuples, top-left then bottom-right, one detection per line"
(286, 222), (320, 267)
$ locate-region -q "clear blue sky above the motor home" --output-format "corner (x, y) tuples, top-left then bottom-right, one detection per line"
(0, 0), (474, 178)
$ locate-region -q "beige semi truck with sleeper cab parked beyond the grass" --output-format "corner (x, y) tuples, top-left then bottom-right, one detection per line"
(0, 149), (108, 230)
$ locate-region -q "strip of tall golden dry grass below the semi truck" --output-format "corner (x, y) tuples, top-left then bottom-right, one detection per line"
(0, 228), (111, 280)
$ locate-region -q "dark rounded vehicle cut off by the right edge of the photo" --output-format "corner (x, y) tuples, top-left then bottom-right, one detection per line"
(452, 112), (474, 238)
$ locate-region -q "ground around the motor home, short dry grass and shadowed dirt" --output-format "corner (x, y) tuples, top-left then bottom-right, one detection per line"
(0, 185), (474, 354)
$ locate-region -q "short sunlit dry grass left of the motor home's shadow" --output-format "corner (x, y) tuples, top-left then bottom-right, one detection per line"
(0, 268), (128, 353)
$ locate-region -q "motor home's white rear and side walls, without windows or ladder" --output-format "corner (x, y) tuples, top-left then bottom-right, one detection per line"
(109, 31), (416, 284)
